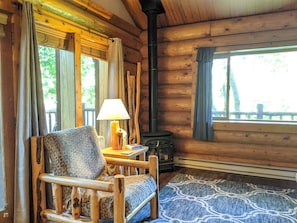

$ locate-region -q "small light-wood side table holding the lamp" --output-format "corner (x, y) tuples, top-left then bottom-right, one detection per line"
(101, 146), (149, 175)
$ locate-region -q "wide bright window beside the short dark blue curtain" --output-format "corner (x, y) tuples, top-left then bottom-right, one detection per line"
(212, 47), (297, 121)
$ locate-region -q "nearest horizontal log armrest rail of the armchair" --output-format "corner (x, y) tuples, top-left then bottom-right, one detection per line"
(39, 173), (114, 192)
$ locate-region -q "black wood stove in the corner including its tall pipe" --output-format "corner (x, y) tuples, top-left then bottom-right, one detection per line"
(139, 0), (174, 171)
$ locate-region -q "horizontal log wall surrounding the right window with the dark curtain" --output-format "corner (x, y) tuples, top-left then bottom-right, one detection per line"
(140, 8), (297, 168)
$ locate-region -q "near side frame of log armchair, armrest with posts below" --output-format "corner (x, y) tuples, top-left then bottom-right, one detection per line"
(39, 173), (125, 222)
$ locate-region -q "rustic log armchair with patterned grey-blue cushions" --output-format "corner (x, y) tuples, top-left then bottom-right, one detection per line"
(31, 126), (159, 223)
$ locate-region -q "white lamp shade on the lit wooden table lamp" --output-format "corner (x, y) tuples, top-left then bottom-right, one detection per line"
(97, 98), (130, 120)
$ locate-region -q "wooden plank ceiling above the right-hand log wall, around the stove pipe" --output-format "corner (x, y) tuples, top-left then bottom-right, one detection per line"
(122, 0), (297, 30)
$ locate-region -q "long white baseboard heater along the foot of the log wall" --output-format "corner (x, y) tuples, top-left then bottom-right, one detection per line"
(174, 156), (297, 181)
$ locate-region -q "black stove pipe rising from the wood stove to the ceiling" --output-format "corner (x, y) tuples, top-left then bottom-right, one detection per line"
(139, 0), (164, 133)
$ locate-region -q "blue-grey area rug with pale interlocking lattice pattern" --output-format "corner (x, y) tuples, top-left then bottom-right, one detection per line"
(129, 174), (297, 223)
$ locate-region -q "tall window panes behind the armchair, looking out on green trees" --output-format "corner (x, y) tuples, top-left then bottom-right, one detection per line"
(39, 46), (107, 132)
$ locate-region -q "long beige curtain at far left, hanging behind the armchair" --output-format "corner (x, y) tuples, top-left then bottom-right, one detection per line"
(14, 2), (47, 223)
